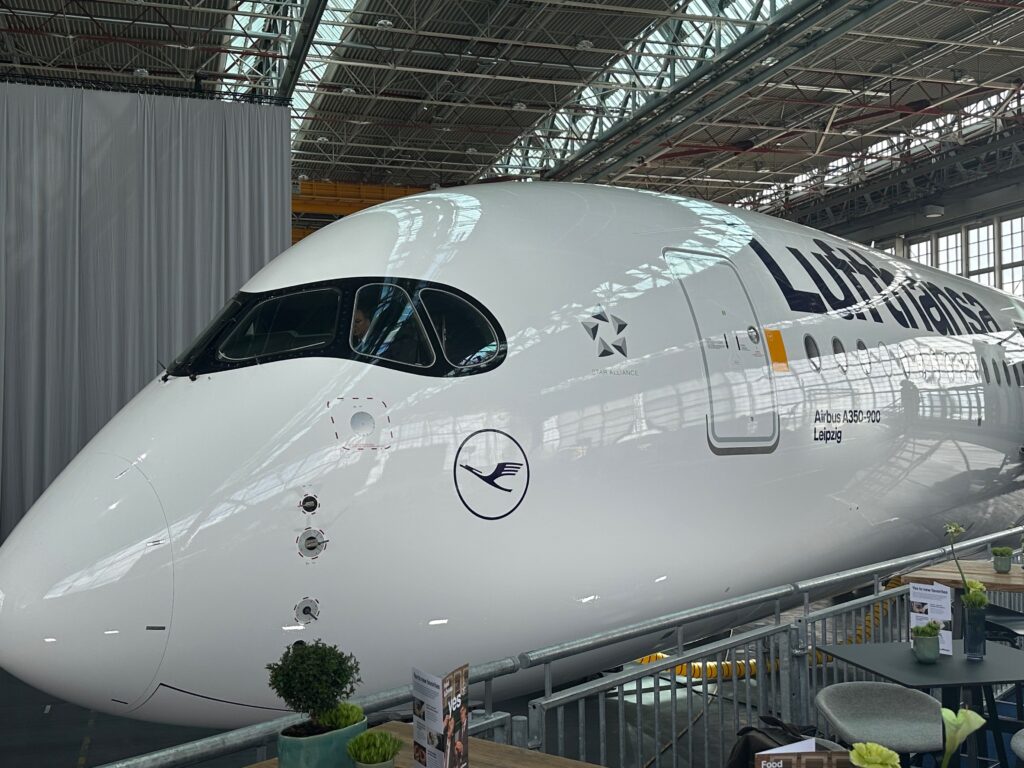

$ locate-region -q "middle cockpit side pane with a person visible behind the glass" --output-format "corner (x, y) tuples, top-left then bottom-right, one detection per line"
(349, 283), (434, 368)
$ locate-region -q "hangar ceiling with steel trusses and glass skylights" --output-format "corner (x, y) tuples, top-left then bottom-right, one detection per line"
(0, 0), (1024, 234)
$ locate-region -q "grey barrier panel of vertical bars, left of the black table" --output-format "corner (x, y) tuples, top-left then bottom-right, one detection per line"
(529, 625), (791, 768)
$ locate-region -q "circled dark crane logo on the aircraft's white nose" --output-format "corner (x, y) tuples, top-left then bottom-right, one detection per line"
(454, 429), (529, 520)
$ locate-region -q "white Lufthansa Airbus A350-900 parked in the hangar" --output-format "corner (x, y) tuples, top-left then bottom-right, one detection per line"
(0, 181), (1024, 728)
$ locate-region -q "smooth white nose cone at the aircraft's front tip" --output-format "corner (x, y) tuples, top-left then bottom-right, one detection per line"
(0, 454), (173, 712)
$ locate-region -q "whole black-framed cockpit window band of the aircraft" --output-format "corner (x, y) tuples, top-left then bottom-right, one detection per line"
(163, 275), (508, 381)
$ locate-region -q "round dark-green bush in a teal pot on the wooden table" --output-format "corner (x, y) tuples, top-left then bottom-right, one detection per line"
(266, 639), (367, 768)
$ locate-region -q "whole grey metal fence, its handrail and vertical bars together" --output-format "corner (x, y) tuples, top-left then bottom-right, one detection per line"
(102, 525), (1024, 768)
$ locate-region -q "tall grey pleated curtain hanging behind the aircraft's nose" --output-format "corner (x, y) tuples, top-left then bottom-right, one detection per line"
(0, 83), (291, 541)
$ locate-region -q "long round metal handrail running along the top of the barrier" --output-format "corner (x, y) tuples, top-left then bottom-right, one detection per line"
(94, 525), (1024, 768)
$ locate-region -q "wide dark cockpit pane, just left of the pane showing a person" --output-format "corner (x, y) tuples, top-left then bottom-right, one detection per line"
(218, 289), (341, 362)
